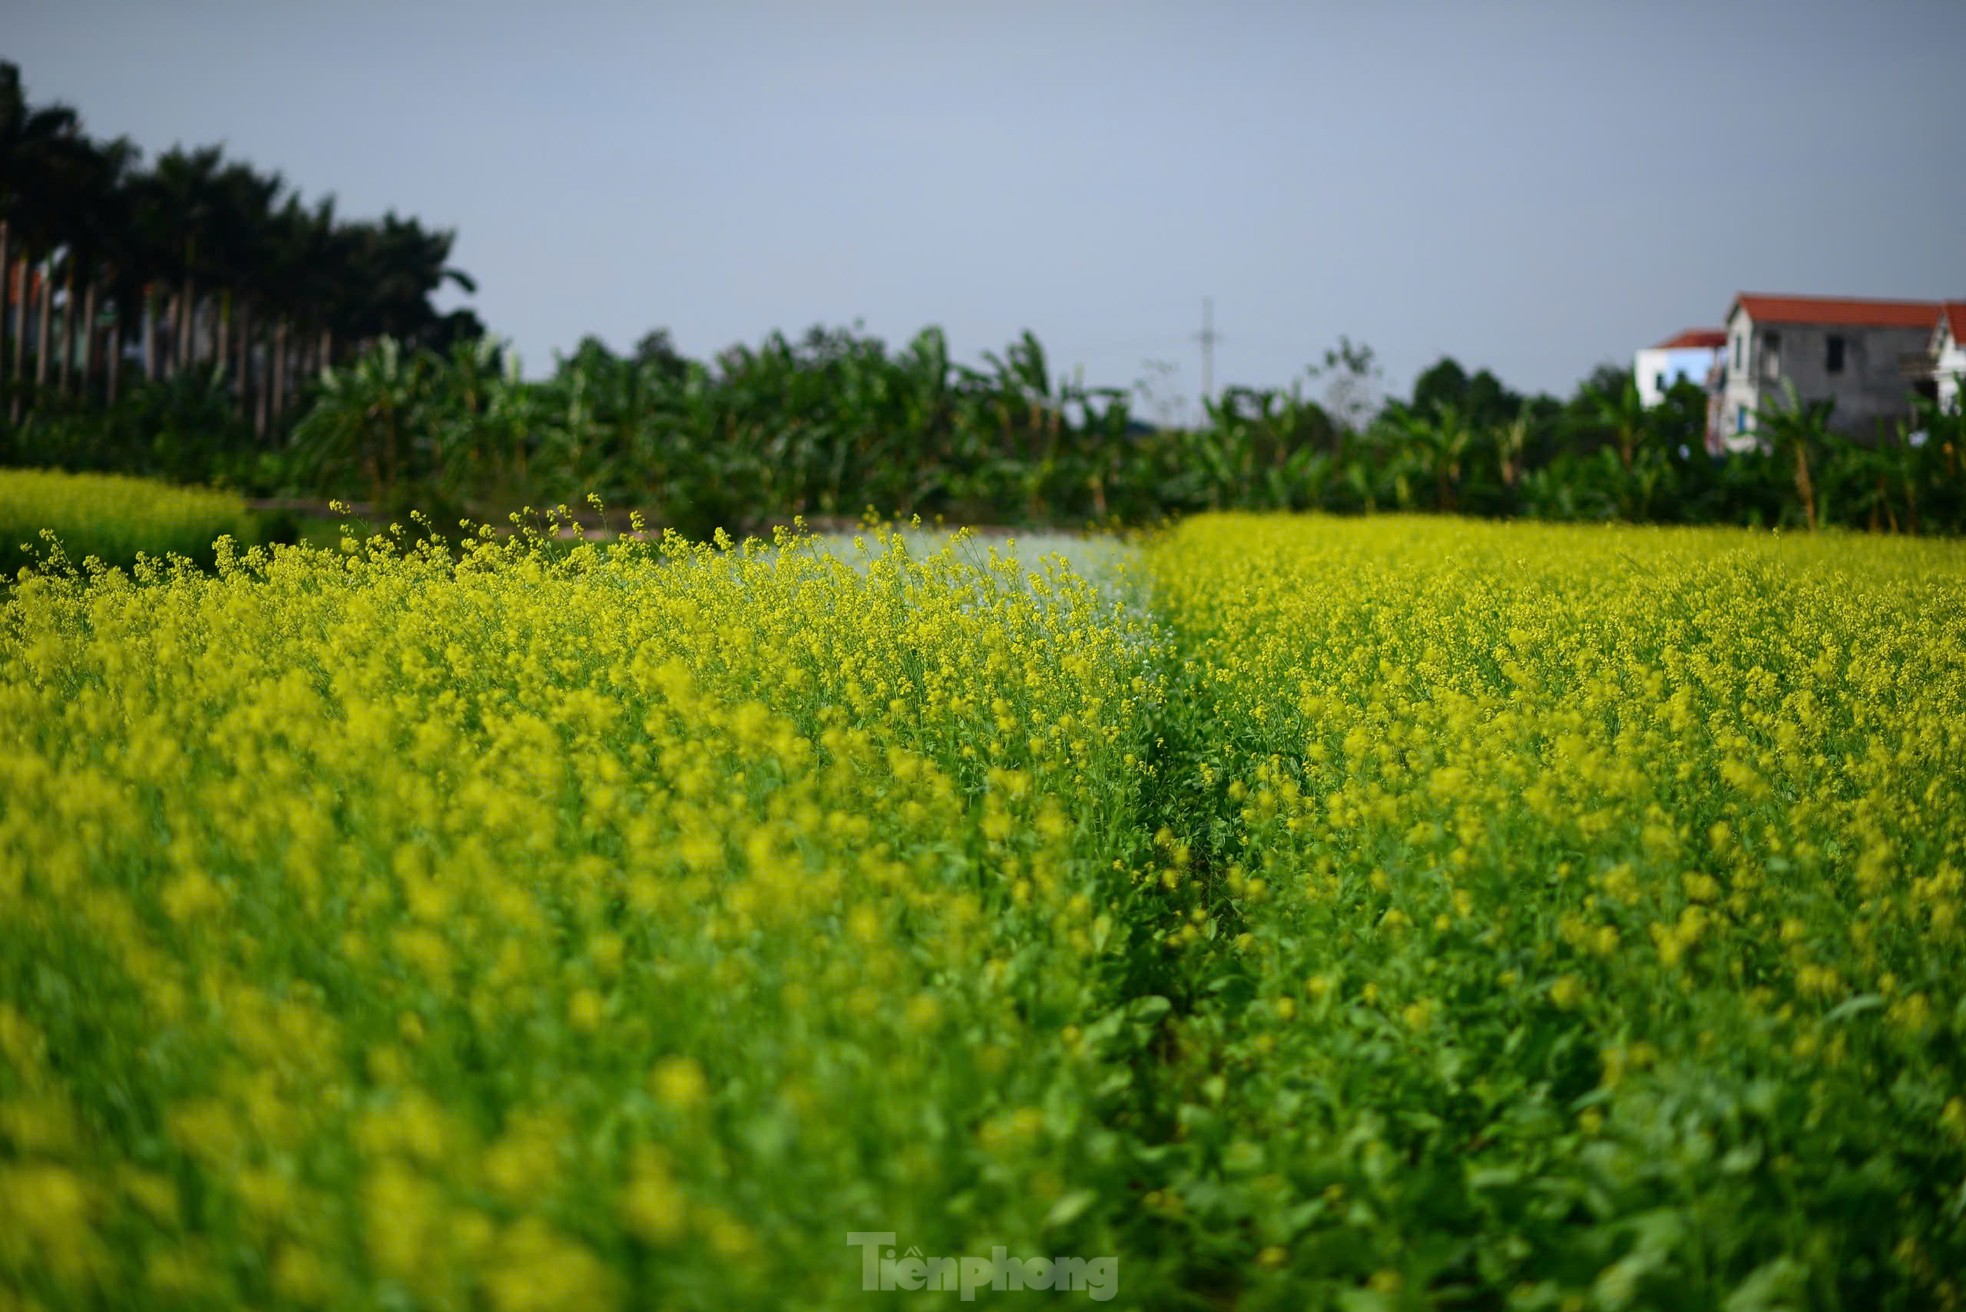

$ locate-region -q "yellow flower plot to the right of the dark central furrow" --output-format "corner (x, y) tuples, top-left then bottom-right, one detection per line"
(1152, 515), (1966, 1308)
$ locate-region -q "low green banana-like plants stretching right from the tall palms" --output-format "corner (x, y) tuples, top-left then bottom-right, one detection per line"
(277, 327), (1966, 535)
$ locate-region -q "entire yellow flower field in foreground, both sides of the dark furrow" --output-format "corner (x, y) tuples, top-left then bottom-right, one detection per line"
(0, 515), (1966, 1312)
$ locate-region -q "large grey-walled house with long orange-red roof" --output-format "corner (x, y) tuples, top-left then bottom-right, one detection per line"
(1708, 291), (1942, 450)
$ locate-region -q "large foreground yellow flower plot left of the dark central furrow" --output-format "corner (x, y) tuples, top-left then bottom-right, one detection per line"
(0, 527), (1154, 1308)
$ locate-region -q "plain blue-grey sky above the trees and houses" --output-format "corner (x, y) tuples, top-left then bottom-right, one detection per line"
(0, 0), (1966, 407)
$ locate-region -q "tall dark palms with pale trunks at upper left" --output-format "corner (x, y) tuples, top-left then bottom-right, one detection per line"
(0, 63), (484, 439)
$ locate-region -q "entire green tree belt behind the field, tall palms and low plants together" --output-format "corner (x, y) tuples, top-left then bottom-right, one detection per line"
(0, 63), (1966, 535)
